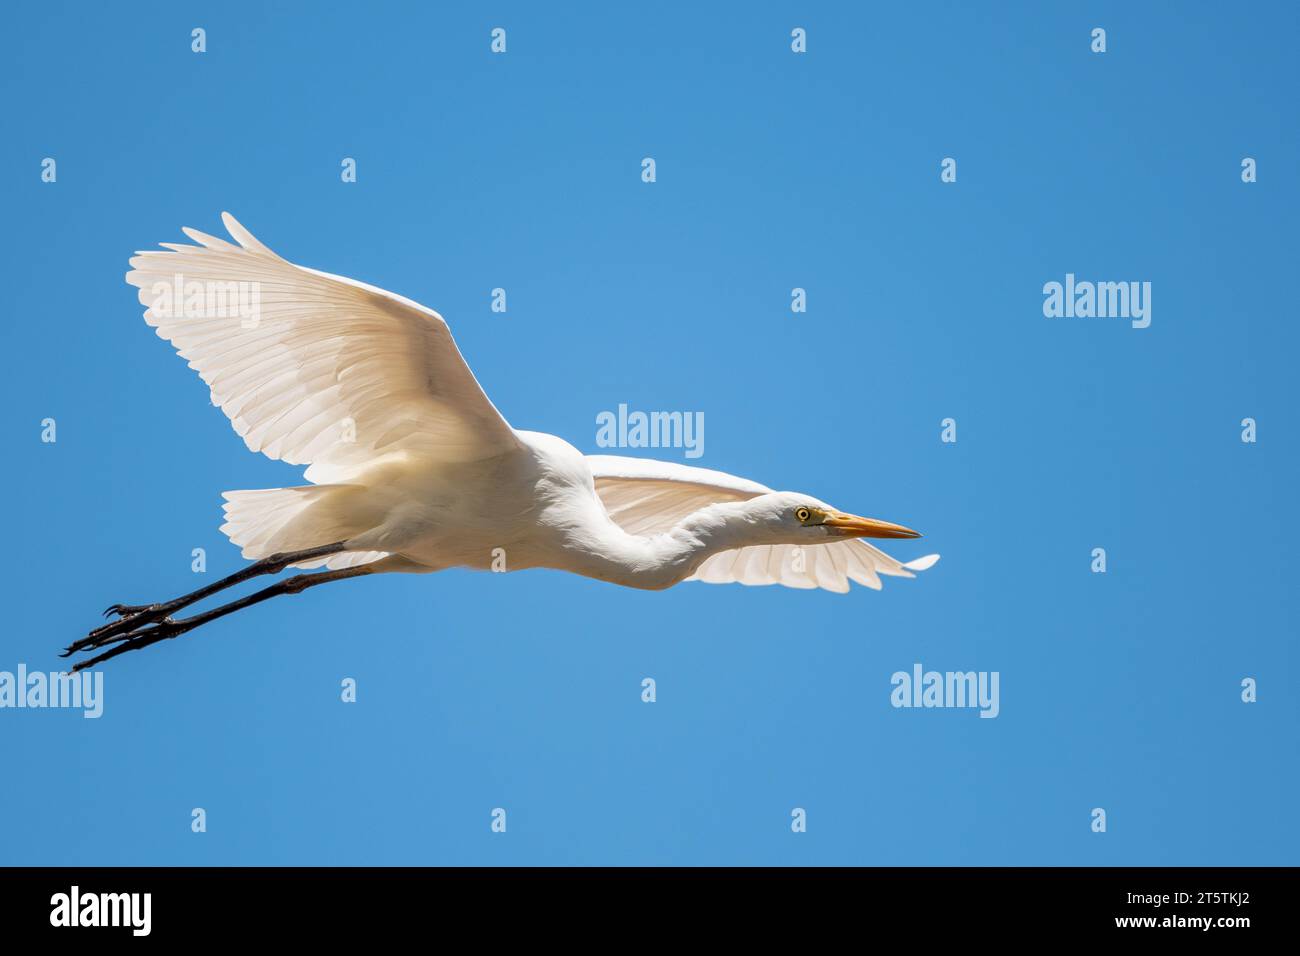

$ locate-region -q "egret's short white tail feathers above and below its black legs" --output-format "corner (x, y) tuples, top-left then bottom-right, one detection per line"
(221, 485), (387, 570)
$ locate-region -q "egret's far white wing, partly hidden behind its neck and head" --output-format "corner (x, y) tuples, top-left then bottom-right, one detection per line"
(586, 455), (939, 593)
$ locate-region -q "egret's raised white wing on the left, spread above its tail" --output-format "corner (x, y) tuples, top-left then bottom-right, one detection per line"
(126, 213), (519, 483)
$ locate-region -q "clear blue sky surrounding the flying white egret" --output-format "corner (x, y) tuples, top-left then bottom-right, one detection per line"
(0, 3), (1300, 865)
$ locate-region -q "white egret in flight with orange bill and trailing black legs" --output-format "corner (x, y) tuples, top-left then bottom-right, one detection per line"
(64, 213), (939, 671)
